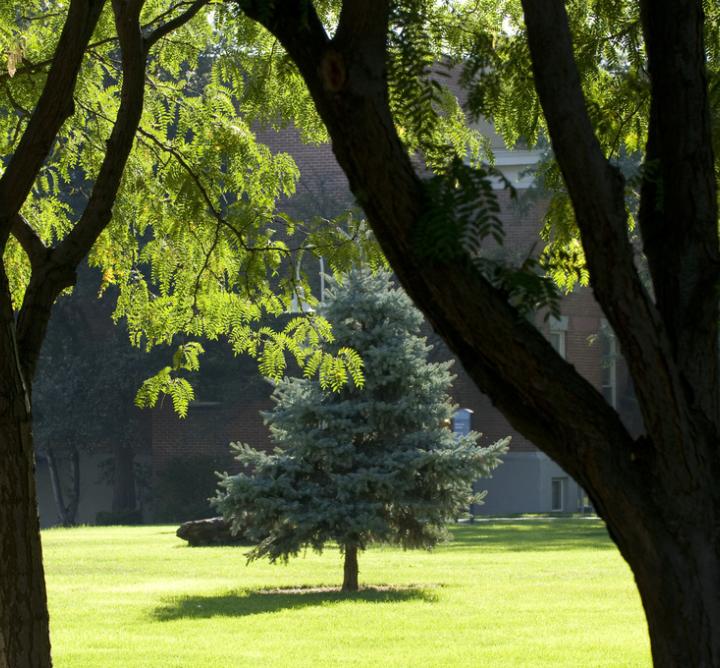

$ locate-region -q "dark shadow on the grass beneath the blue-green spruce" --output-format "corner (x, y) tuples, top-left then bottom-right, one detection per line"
(152, 586), (437, 622)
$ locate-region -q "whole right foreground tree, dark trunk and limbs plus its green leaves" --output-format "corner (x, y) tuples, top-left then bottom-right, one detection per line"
(229, 0), (720, 666)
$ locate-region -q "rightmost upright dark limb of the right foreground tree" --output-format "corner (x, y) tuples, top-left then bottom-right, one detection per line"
(640, 0), (720, 428)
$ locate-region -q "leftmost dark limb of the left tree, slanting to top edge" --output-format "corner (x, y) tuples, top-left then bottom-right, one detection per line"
(0, 0), (104, 240)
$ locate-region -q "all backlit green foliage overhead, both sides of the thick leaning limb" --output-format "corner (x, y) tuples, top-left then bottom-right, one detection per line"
(0, 0), (680, 412)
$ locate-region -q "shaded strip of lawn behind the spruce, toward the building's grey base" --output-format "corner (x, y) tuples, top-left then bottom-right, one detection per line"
(443, 518), (616, 552)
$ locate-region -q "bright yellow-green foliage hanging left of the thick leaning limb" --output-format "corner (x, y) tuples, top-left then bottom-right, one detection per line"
(0, 0), (382, 413)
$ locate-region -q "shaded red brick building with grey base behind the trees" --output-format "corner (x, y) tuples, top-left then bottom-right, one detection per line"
(33, 120), (640, 526)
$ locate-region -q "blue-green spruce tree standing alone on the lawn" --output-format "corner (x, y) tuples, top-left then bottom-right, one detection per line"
(215, 270), (507, 591)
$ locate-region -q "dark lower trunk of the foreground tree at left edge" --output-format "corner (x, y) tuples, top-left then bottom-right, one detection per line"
(0, 275), (51, 668)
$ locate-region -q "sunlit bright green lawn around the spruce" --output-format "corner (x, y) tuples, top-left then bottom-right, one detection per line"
(43, 519), (650, 668)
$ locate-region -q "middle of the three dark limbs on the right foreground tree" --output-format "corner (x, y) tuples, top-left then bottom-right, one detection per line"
(523, 0), (686, 454)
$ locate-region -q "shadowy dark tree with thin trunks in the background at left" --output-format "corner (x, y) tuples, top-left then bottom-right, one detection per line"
(33, 269), (159, 526)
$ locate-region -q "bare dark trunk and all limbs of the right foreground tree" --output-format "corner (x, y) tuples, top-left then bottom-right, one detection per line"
(238, 0), (720, 667)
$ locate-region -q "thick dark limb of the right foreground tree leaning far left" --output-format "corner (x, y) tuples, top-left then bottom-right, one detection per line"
(235, 0), (652, 536)
